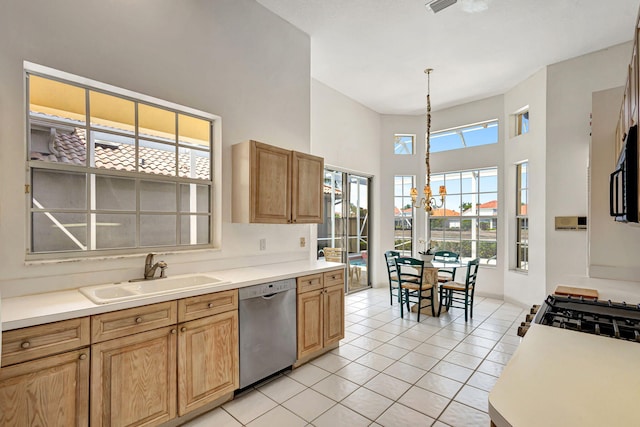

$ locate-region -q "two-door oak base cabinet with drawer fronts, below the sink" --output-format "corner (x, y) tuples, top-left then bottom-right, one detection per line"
(91, 289), (239, 426)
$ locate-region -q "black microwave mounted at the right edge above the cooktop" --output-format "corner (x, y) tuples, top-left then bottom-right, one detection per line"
(609, 125), (638, 222)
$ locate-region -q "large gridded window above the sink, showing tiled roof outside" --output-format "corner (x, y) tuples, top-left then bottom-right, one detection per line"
(26, 66), (219, 258)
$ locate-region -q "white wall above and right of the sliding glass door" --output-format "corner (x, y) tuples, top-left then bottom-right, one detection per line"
(311, 80), (387, 285)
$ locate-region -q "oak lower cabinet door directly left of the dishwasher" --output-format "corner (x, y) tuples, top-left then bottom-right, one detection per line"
(178, 311), (240, 415)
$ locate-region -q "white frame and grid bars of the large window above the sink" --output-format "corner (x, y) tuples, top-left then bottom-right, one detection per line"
(23, 61), (222, 261)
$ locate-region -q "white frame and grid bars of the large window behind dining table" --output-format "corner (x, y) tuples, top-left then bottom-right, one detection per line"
(426, 166), (500, 267)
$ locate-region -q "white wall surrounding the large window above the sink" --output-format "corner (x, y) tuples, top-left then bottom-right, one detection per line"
(0, 0), (315, 298)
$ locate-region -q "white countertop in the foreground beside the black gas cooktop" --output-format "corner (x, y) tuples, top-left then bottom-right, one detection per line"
(489, 324), (640, 427)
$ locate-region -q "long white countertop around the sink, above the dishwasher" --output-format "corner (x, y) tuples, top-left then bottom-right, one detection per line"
(1, 261), (344, 331)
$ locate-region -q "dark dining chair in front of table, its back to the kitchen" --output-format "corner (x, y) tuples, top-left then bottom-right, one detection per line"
(395, 257), (436, 322)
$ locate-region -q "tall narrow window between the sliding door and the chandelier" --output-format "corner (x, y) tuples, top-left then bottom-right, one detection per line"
(393, 175), (414, 256)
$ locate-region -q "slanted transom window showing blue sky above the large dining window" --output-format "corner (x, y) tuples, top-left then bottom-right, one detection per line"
(430, 120), (498, 153)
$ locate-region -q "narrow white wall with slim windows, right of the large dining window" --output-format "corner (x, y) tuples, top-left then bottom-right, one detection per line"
(501, 68), (547, 305)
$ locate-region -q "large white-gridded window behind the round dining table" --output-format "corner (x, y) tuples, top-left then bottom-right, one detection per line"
(429, 168), (499, 265)
